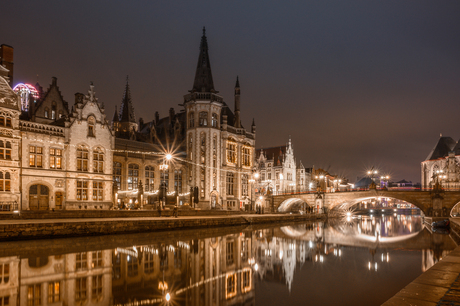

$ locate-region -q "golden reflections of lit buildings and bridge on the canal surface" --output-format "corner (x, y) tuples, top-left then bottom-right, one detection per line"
(0, 216), (449, 306)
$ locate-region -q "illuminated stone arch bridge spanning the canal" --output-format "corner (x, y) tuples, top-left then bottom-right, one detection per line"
(272, 189), (460, 217)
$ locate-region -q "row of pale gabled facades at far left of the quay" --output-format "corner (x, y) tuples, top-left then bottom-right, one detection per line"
(0, 51), (114, 211)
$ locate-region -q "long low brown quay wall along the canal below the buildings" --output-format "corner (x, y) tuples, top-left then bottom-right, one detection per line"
(0, 215), (324, 241)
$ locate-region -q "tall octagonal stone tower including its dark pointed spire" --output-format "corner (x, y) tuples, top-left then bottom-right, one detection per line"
(184, 28), (224, 209)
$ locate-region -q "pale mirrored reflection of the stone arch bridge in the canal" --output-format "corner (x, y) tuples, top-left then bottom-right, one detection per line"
(274, 226), (456, 250)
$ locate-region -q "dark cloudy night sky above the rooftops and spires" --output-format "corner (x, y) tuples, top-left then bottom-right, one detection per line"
(0, 0), (460, 182)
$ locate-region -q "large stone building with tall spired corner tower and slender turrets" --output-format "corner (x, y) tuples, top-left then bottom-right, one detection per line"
(112, 30), (256, 210)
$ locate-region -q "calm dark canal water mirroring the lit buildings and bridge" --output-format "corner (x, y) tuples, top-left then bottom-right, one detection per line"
(0, 215), (456, 306)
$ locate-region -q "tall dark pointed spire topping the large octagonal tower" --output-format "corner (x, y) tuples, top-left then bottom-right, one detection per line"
(191, 27), (216, 92)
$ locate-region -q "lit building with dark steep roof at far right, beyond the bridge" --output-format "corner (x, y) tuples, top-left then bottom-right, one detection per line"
(421, 136), (460, 190)
